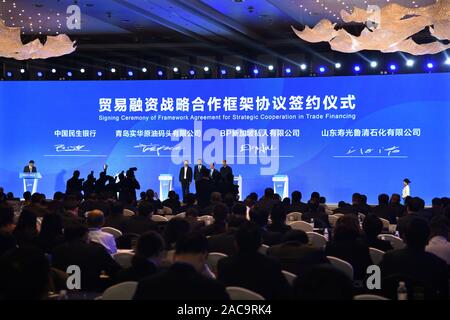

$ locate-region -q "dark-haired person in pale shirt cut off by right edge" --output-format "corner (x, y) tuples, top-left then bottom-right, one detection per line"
(425, 216), (450, 265)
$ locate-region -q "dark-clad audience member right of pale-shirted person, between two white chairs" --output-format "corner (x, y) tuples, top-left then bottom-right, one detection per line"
(122, 201), (158, 234)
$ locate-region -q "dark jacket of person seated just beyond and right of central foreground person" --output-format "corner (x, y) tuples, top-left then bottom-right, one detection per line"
(267, 241), (328, 274)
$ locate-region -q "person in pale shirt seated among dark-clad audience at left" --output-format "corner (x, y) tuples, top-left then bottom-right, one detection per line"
(86, 210), (117, 254)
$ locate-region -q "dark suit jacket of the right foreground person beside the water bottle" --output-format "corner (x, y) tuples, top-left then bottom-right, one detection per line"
(380, 247), (449, 299)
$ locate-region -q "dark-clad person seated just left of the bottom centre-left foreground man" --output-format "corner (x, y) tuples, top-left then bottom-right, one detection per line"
(116, 231), (165, 283)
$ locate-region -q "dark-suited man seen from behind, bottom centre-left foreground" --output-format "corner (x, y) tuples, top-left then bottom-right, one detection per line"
(134, 233), (229, 301)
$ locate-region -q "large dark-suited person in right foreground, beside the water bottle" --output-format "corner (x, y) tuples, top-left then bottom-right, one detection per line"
(380, 216), (449, 299)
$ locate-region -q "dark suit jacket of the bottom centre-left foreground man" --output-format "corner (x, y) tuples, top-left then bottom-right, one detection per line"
(134, 263), (229, 301)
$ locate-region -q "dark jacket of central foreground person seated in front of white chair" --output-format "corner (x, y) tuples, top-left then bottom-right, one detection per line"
(217, 252), (291, 300)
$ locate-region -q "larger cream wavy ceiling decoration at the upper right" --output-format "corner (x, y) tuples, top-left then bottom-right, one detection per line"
(293, 0), (450, 55)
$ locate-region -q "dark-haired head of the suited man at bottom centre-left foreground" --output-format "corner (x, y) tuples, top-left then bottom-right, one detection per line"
(173, 233), (208, 272)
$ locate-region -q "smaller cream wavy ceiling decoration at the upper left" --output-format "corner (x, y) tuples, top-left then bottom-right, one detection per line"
(0, 20), (76, 60)
